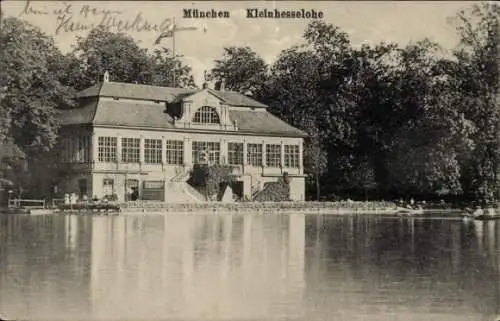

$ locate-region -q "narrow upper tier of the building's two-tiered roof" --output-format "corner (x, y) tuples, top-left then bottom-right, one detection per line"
(76, 82), (267, 108)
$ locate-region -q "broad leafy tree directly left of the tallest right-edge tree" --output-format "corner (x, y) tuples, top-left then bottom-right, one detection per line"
(380, 40), (472, 194)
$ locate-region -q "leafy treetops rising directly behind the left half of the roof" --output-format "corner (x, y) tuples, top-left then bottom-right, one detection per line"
(65, 27), (194, 90)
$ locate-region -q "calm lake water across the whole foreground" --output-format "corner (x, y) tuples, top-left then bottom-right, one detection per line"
(0, 214), (500, 321)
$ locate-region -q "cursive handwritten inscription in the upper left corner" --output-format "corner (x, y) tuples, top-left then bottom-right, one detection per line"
(19, 0), (173, 35)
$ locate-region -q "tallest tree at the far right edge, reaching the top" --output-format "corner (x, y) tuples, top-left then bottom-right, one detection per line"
(455, 2), (500, 202)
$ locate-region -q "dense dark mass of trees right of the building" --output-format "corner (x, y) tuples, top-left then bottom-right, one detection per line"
(212, 4), (500, 201)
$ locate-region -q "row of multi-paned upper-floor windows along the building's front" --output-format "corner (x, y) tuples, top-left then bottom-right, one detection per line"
(92, 137), (300, 168)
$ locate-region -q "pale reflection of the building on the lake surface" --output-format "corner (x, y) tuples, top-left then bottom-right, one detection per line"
(90, 211), (305, 319)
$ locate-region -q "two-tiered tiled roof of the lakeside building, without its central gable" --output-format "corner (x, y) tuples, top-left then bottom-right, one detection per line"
(59, 82), (306, 137)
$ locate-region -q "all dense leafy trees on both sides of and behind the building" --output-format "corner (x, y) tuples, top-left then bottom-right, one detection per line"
(0, 3), (500, 201)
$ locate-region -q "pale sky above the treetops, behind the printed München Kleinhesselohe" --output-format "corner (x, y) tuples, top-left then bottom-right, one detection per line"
(1, 0), (477, 84)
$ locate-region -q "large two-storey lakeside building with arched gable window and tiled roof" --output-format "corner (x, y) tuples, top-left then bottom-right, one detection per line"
(58, 75), (306, 202)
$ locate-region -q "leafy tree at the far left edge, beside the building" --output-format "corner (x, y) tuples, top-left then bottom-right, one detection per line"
(0, 18), (72, 156)
